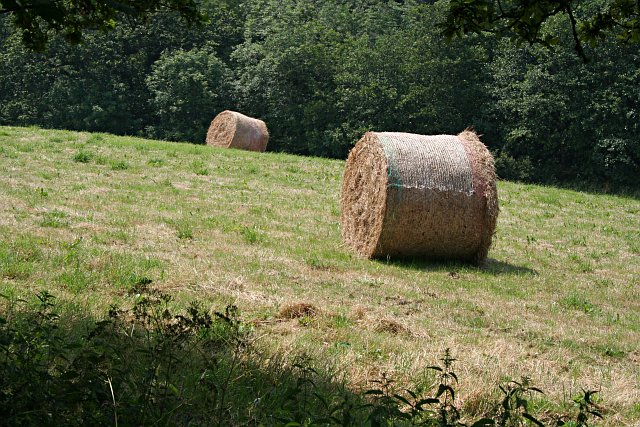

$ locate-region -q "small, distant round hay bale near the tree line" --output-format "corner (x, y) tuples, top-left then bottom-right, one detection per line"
(206, 110), (269, 152)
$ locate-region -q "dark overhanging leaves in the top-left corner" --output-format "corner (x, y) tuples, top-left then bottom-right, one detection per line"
(0, 0), (204, 50)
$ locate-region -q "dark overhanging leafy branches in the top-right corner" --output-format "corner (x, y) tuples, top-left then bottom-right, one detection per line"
(444, 0), (640, 60)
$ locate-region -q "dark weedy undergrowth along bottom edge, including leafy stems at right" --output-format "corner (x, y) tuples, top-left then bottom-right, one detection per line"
(0, 290), (602, 427)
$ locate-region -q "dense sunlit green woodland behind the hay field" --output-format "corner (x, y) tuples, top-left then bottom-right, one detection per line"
(0, 0), (640, 190)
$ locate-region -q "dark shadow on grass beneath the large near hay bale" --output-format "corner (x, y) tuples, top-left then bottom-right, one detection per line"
(374, 258), (538, 276)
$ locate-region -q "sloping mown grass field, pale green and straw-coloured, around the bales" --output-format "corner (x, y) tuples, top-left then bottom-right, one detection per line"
(0, 127), (640, 426)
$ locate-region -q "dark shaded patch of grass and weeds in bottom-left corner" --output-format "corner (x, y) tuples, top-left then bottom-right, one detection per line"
(0, 293), (371, 426)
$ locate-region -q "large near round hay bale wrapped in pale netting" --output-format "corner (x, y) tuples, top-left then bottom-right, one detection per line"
(341, 131), (498, 262)
